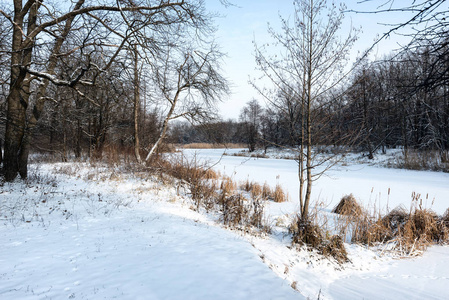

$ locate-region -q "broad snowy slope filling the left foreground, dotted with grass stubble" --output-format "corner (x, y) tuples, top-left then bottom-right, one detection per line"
(0, 165), (301, 299)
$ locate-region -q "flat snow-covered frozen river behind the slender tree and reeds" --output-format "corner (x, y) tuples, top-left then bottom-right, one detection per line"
(184, 149), (449, 214)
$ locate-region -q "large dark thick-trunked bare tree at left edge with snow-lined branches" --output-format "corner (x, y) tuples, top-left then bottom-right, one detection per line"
(0, 0), (207, 181)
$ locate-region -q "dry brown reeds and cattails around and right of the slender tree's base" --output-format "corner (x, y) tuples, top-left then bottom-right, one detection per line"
(289, 195), (449, 263)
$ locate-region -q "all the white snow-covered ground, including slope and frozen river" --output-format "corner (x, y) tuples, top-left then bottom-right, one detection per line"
(0, 150), (449, 299)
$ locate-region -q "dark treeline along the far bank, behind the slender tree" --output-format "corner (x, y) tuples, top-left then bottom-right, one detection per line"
(170, 44), (449, 157)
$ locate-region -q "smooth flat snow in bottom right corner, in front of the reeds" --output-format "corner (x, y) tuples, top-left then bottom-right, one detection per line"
(328, 247), (449, 299)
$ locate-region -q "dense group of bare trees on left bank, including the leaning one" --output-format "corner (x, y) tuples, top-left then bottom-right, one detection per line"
(0, 0), (227, 181)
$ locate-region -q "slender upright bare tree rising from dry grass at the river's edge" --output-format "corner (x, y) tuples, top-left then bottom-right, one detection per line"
(254, 0), (356, 221)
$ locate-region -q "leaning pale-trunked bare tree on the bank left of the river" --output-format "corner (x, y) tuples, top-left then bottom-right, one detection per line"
(145, 43), (228, 161)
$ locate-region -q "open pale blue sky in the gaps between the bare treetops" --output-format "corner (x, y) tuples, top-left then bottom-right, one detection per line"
(206, 0), (416, 119)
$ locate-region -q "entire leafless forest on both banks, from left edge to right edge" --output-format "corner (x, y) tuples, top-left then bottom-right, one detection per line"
(0, 0), (449, 180)
